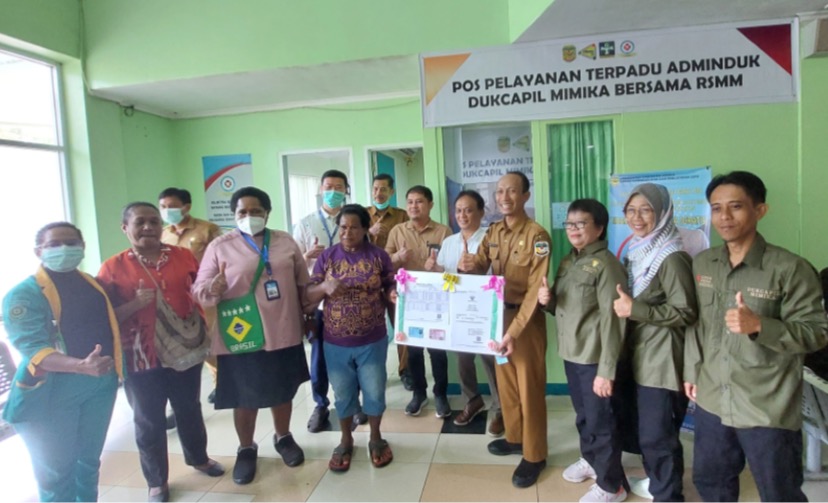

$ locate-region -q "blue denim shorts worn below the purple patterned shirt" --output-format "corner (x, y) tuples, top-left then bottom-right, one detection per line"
(324, 337), (388, 418)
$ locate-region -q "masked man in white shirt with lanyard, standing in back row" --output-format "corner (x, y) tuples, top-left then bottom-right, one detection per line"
(293, 169), (358, 433)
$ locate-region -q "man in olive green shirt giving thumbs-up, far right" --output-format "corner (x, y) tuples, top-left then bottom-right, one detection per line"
(684, 171), (828, 501)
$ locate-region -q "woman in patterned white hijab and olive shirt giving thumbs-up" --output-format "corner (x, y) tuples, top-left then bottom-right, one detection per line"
(613, 183), (698, 501)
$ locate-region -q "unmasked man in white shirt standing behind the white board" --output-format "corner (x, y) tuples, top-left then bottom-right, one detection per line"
(425, 190), (504, 437)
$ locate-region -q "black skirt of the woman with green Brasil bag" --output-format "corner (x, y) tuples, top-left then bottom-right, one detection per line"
(215, 344), (310, 409)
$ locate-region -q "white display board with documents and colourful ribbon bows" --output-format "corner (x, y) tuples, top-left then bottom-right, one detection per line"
(394, 269), (505, 355)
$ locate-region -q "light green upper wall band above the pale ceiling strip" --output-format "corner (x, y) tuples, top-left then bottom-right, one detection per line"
(83, 0), (510, 89)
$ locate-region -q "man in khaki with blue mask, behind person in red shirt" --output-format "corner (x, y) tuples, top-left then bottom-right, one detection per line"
(158, 187), (221, 408)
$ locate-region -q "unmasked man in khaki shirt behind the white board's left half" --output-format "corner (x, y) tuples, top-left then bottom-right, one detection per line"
(385, 185), (451, 418)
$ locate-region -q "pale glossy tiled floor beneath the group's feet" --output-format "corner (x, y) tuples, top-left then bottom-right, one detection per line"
(0, 344), (828, 501)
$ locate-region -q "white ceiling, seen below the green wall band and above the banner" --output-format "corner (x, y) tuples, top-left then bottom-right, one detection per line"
(92, 0), (828, 118)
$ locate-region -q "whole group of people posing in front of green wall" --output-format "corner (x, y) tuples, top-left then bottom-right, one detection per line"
(3, 170), (828, 501)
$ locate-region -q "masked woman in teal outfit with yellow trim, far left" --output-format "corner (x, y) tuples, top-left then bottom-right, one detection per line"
(3, 222), (123, 501)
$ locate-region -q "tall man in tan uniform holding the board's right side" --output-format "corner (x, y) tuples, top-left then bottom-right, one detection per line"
(458, 172), (551, 487)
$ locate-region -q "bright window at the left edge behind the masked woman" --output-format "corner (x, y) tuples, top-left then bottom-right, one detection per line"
(0, 50), (69, 316)
